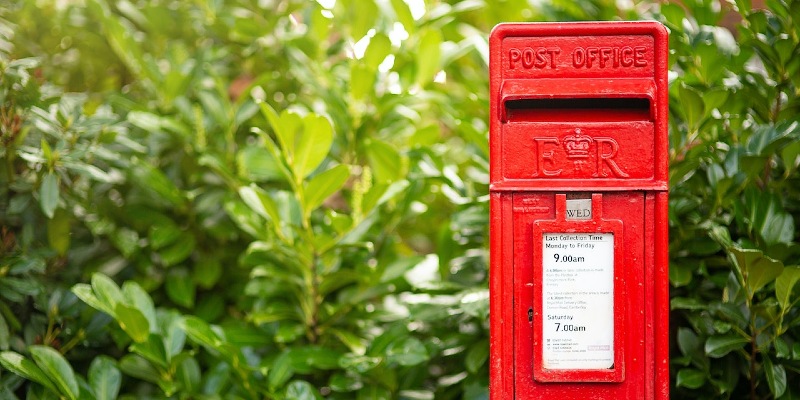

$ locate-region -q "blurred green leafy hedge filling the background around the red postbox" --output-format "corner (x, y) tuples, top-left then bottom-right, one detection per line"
(0, 0), (800, 399)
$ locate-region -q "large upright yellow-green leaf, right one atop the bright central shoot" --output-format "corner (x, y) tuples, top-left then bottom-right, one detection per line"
(292, 114), (333, 179)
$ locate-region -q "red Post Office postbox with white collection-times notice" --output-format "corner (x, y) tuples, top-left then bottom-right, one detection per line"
(489, 22), (669, 400)
